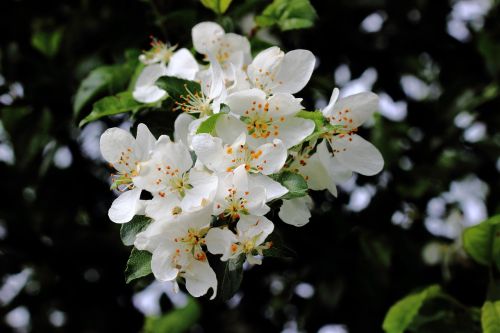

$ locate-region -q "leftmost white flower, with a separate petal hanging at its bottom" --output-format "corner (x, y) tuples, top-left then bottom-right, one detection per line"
(100, 124), (156, 223)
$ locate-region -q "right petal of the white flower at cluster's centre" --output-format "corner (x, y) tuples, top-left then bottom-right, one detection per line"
(251, 139), (288, 175)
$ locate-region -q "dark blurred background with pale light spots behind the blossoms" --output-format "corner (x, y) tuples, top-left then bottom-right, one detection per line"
(0, 0), (500, 333)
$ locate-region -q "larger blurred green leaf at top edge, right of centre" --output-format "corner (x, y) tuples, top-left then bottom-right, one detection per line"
(256, 0), (317, 31)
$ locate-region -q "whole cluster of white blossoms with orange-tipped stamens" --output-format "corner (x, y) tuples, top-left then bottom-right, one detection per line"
(100, 22), (383, 298)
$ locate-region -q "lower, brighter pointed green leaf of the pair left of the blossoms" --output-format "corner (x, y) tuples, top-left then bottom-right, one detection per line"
(79, 91), (145, 127)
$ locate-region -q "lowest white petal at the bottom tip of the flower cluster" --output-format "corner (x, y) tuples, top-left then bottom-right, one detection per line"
(183, 260), (217, 299)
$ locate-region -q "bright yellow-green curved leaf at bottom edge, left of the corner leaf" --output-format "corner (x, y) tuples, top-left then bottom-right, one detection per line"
(382, 285), (441, 333)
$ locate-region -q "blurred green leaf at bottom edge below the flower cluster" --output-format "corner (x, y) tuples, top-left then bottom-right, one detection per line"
(143, 297), (201, 333)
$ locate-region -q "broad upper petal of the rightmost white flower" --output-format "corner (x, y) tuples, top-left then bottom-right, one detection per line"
(331, 92), (378, 128)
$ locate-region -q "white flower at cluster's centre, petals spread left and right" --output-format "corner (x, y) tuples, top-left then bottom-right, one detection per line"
(192, 133), (288, 175)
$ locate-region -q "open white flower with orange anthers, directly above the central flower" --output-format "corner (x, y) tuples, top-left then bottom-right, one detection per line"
(226, 88), (315, 148)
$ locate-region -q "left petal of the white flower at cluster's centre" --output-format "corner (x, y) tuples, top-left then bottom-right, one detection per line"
(191, 133), (224, 171)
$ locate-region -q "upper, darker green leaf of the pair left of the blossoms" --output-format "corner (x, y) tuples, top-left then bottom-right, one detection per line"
(73, 51), (140, 117)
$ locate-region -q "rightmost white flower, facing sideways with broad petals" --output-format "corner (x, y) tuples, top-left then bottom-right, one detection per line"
(322, 88), (384, 176)
